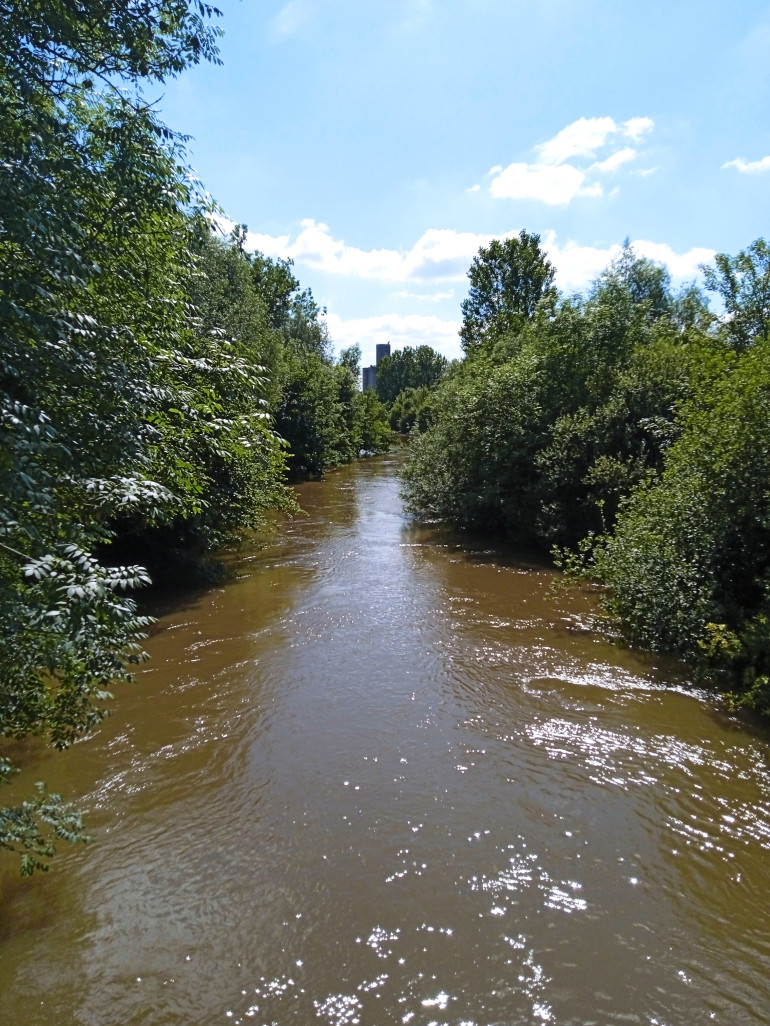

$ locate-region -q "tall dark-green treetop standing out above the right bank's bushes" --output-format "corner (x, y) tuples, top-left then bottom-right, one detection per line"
(460, 231), (555, 355)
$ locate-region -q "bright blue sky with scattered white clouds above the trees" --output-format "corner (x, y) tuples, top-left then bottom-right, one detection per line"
(160, 0), (770, 363)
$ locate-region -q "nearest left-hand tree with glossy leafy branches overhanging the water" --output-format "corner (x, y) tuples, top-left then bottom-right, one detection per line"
(0, 0), (225, 873)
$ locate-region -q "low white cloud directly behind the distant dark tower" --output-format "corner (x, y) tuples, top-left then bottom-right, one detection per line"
(326, 314), (462, 365)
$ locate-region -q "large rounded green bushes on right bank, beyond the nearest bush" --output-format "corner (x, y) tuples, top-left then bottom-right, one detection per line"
(405, 246), (696, 546)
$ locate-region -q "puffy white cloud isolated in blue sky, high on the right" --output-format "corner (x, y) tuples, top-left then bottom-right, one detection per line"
(490, 117), (654, 206)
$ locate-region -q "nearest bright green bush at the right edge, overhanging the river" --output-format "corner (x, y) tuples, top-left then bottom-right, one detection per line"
(594, 343), (770, 690)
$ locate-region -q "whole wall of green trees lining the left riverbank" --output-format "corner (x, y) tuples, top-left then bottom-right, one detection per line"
(0, 0), (389, 873)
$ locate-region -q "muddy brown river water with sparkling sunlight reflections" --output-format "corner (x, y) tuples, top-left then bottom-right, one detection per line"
(0, 456), (770, 1026)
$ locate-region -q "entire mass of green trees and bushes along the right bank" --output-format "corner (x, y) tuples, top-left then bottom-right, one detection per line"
(405, 232), (770, 713)
